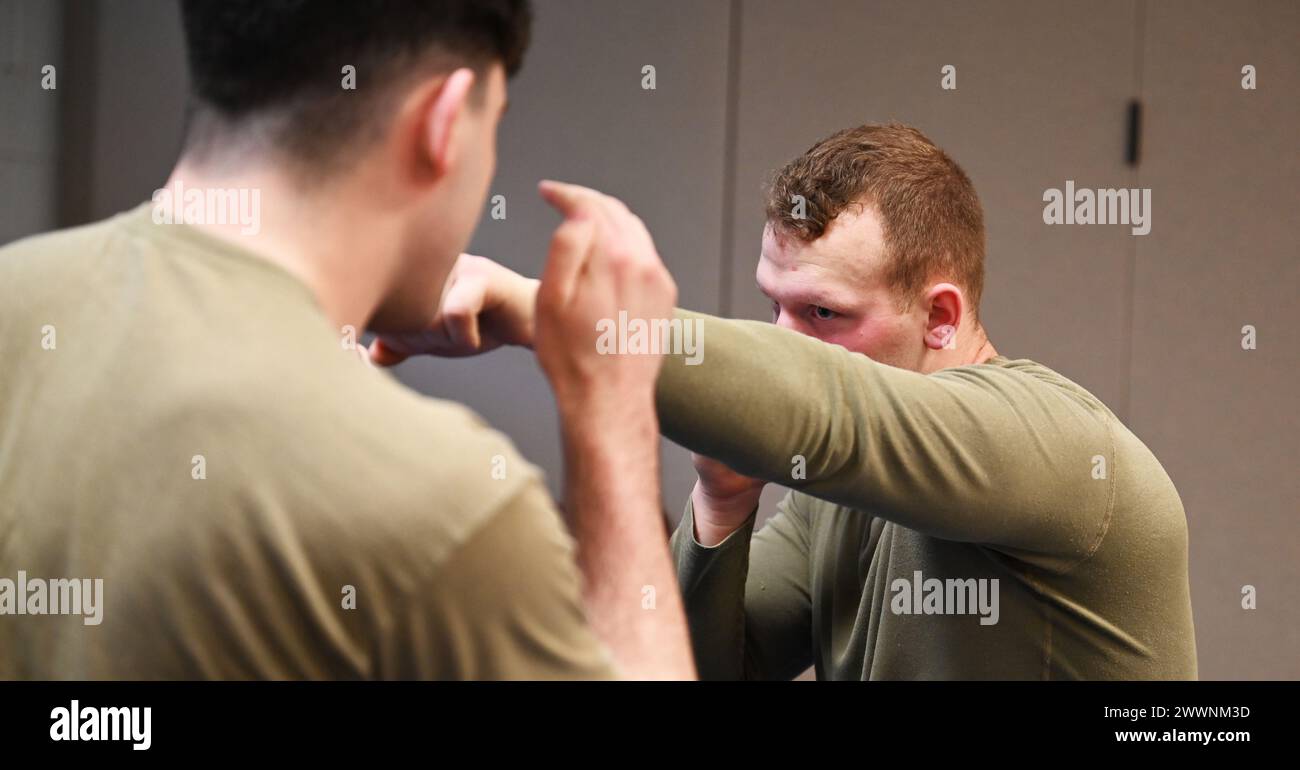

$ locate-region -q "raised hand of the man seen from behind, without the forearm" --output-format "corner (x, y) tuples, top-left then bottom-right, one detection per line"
(536, 182), (677, 411)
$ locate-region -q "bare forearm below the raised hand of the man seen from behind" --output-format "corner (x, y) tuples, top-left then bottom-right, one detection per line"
(562, 392), (696, 679)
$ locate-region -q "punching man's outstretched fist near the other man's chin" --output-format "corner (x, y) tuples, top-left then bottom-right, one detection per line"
(371, 254), (537, 367)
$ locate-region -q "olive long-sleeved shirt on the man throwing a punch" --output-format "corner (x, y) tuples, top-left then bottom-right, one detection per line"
(658, 312), (1196, 680)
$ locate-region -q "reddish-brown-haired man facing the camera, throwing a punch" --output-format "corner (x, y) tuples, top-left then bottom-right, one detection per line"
(384, 125), (1196, 679)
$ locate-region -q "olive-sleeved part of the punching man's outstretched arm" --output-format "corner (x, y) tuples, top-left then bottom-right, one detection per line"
(657, 311), (1114, 558)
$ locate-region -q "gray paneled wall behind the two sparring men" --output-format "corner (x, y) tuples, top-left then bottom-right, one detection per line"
(0, 0), (1300, 679)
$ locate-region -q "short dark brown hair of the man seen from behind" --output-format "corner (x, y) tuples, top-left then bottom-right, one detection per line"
(181, 0), (532, 168)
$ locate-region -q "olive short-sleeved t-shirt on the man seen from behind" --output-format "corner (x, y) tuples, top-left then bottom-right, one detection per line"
(0, 204), (615, 679)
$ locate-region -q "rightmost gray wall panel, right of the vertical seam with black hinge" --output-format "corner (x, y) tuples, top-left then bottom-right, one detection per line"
(1130, 0), (1300, 679)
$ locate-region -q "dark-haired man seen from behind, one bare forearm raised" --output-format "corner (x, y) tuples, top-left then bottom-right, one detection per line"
(0, 0), (694, 679)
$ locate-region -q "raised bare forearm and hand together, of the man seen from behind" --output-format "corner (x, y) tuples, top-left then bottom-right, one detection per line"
(534, 182), (696, 679)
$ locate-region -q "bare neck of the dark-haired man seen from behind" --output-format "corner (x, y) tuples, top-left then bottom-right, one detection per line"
(166, 159), (399, 332)
